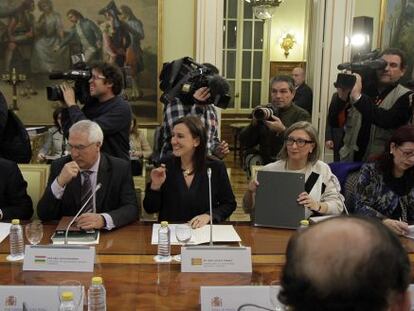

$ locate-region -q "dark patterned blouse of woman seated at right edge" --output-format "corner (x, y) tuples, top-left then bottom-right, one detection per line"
(355, 163), (414, 222)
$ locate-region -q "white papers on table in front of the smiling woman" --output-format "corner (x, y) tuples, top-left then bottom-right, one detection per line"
(151, 224), (241, 245)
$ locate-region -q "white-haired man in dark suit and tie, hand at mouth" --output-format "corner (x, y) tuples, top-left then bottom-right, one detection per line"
(38, 120), (138, 230)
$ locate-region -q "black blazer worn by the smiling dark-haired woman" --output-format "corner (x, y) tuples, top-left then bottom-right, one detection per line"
(144, 157), (236, 222)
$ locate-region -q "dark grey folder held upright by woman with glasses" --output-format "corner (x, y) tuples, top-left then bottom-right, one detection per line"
(254, 171), (305, 229)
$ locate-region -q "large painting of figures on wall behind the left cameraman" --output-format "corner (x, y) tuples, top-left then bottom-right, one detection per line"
(0, 0), (162, 125)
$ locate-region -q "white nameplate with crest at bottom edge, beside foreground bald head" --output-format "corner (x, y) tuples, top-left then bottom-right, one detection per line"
(200, 286), (284, 311)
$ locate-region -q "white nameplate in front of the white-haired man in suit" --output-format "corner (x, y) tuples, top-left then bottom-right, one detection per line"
(23, 245), (95, 272)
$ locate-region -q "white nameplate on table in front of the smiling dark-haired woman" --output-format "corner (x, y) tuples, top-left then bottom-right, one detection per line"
(181, 246), (252, 273)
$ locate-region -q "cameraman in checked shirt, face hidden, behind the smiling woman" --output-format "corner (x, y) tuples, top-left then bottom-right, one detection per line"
(160, 63), (230, 159)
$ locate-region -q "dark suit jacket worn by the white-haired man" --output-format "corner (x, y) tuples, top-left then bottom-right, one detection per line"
(37, 152), (138, 227)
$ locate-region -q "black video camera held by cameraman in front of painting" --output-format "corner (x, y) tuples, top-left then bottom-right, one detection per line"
(46, 54), (92, 104)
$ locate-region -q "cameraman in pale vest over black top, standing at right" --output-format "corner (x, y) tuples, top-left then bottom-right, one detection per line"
(340, 48), (412, 161)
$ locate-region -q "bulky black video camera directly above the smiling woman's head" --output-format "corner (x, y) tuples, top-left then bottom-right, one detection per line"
(159, 57), (231, 109)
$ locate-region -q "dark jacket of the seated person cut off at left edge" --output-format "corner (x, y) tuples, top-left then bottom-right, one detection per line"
(0, 158), (33, 219)
